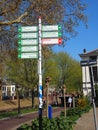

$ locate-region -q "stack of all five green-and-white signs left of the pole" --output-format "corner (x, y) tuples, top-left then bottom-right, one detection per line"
(18, 26), (38, 59)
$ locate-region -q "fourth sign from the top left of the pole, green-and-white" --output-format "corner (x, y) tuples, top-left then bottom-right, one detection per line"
(18, 46), (38, 52)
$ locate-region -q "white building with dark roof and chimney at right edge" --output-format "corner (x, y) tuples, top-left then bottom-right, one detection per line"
(79, 49), (98, 95)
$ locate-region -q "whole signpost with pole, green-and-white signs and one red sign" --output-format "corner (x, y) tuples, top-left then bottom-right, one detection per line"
(18, 17), (62, 130)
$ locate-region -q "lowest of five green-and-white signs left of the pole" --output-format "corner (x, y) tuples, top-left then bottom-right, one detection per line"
(18, 52), (38, 59)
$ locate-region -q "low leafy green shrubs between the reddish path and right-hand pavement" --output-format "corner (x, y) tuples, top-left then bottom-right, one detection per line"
(17, 105), (91, 130)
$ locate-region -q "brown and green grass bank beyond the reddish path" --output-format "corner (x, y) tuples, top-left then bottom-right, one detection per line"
(0, 98), (38, 119)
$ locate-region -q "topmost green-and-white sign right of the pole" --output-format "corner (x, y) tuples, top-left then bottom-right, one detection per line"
(42, 25), (61, 31)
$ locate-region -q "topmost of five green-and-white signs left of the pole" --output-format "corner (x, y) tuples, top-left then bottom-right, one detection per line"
(18, 26), (38, 32)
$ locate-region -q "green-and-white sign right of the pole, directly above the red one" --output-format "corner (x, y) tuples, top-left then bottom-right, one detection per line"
(42, 32), (62, 38)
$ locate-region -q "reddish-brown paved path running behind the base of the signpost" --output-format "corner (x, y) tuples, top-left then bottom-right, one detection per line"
(0, 107), (64, 130)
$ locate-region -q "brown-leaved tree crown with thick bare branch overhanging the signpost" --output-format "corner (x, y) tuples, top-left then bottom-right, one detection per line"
(0, 0), (87, 103)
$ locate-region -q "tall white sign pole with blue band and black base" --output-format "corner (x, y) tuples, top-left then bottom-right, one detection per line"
(38, 17), (43, 130)
